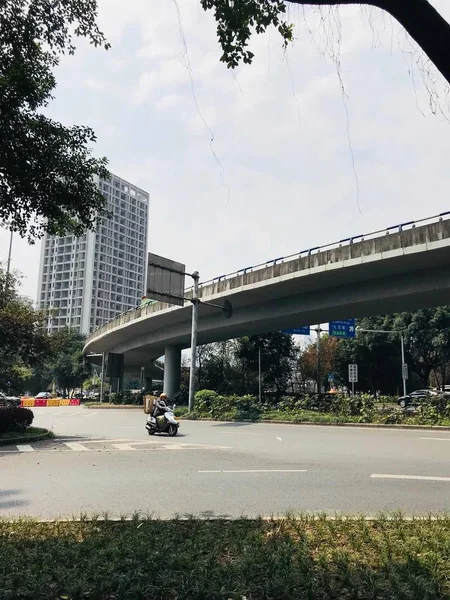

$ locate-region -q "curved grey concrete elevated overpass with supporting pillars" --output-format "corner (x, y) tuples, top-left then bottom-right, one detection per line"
(84, 211), (450, 394)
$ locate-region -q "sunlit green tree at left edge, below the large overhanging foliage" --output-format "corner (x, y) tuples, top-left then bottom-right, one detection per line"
(0, 268), (49, 393)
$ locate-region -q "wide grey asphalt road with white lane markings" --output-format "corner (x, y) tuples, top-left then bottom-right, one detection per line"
(0, 407), (450, 518)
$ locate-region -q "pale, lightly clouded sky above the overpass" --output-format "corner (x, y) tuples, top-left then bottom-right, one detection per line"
(0, 0), (450, 298)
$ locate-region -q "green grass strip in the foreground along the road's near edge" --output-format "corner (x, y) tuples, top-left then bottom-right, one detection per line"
(0, 515), (450, 600)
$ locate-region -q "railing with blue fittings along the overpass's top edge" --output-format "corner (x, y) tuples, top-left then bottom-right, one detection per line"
(88, 211), (450, 340)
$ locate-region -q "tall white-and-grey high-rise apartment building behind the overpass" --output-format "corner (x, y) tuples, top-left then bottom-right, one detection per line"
(37, 174), (149, 334)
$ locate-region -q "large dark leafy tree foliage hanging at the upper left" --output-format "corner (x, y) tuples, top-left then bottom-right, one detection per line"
(0, 0), (108, 242)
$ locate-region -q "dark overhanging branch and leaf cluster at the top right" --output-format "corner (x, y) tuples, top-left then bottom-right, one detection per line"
(200, 0), (450, 82)
